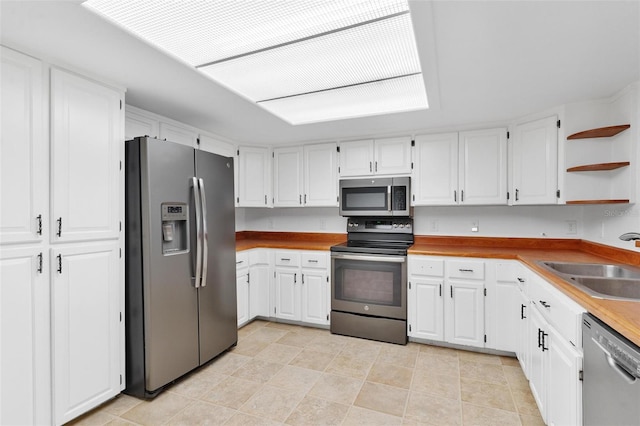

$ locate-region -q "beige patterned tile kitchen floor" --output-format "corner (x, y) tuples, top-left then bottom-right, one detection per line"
(73, 321), (544, 425)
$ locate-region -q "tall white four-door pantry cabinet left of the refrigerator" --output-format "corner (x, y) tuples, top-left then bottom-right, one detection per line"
(0, 47), (124, 424)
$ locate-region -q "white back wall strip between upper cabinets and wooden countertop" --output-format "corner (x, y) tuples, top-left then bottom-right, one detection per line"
(236, 206), (583, 238)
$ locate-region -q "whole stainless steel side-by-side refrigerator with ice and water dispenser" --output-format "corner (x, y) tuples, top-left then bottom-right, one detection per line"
(125, 137), (238, 398)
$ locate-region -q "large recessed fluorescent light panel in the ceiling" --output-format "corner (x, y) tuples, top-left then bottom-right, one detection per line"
(84, 0), (428, 124)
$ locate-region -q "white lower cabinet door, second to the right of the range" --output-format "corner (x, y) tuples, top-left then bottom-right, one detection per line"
(444, 281), (484, 348)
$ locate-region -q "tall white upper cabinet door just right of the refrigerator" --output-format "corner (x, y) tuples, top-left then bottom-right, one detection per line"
(236, 146), (271, 207)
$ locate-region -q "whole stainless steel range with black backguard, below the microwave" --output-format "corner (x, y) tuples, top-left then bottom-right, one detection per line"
(331, 217), (413, 345)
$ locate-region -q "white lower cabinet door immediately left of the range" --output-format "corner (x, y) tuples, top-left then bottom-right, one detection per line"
(301, 269), (329, 325)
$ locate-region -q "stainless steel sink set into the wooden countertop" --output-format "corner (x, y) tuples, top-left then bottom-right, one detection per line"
(538, 262), (640, 301)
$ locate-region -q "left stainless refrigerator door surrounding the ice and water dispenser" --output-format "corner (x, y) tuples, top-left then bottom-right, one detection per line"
(140, 139), (199, 391)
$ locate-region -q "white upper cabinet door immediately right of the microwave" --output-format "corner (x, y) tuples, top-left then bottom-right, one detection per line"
(411, 133), (458, 206)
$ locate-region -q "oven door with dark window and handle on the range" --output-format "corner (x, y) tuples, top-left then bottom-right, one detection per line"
(331, 253), (407, 320)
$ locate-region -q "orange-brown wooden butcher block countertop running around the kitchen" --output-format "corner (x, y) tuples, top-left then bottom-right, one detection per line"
(236, 231), (640, 346)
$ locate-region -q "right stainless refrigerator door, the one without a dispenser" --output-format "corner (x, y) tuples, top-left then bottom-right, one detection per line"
(196, 151), (238, 364)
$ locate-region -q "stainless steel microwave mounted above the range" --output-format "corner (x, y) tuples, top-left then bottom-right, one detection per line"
(340, 177), (411, 216)
